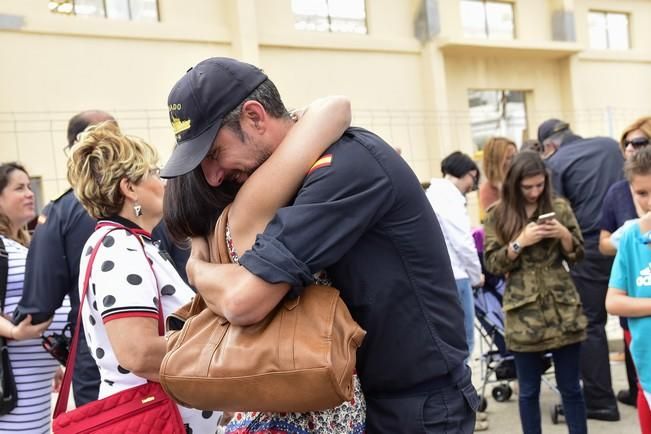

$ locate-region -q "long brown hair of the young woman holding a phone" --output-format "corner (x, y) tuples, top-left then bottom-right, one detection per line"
(493, 151), (553, 244)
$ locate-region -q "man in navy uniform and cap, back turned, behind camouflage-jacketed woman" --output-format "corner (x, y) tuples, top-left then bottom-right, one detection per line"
(538, 119), (624, 421)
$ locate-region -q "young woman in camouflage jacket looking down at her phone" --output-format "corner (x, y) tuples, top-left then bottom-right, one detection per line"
(484, 152), (587, 434)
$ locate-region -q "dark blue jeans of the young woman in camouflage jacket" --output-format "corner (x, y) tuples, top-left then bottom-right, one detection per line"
(513, 343), (588, 434)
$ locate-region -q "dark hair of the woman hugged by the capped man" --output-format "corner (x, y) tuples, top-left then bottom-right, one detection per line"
(163, 166), (240, 243)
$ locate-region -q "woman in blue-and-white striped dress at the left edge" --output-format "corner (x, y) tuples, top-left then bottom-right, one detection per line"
(0, 163), (70, 433)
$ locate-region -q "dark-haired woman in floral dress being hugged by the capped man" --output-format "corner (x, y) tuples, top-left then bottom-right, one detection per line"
(165, 97), (366, 434)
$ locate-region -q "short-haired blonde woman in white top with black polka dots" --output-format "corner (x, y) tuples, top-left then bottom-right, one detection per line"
(68, 122), (221, 434)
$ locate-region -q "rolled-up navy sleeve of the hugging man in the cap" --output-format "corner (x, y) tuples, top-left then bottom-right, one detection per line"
(240, 135), (395, 289)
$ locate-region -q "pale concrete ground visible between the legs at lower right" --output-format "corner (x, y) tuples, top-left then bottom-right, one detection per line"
(471, 319), (640, 434)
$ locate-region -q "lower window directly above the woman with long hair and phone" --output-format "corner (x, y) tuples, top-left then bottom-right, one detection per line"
(468, 90), (527, 149)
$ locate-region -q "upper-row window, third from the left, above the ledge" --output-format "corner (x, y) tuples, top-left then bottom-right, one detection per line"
(461, 0), (515, 39)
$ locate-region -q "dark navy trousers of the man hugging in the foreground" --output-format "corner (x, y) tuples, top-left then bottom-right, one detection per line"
(366, 365), (479, 434)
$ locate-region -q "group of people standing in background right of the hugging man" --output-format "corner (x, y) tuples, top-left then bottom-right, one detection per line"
(427, 113), (651, 433)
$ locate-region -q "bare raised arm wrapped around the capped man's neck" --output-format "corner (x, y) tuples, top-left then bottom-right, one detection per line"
(229, 96), (351, 254)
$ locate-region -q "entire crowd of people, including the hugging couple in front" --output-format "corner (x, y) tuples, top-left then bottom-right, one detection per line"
(0, 58), (651, 434)
